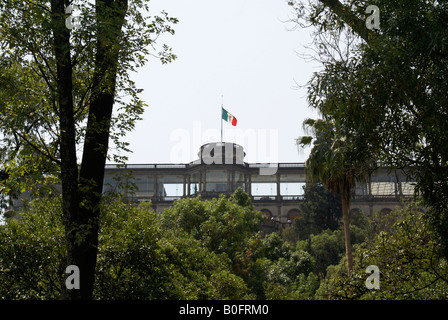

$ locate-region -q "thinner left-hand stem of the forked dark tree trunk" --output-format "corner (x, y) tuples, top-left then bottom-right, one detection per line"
(51, 0), (85, 299)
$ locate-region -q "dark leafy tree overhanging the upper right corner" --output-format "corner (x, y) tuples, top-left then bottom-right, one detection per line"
(290, 0), (448, 257)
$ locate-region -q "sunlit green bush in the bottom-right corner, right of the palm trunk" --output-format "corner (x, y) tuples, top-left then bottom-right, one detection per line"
(320, 206), (448, 300)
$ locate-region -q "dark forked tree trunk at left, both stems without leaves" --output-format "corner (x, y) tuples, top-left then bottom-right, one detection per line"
(51, 0), (127, 300)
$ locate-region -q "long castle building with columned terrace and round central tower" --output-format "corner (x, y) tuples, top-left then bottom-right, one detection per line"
(103, 142), (414, 225)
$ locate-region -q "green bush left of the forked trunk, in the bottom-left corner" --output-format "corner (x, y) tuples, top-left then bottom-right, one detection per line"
(0, 198), (66, 299)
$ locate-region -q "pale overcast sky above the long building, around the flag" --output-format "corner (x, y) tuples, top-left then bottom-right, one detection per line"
(117, 0), (318, 163)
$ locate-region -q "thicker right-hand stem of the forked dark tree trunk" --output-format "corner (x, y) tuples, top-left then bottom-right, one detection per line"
(68, 0), (127, 299)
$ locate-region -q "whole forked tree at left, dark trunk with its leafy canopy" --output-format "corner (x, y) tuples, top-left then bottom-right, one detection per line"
(0, 0), (177, 299)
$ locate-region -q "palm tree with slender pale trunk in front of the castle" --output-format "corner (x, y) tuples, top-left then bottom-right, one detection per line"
(296, 119), (368, 275)
